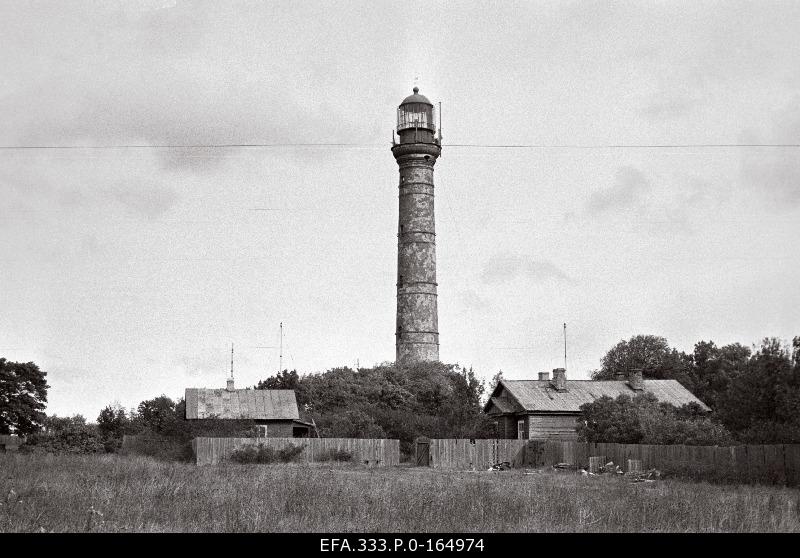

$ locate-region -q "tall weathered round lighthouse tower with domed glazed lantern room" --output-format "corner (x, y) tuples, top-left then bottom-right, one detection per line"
(392, 87), (442, 364)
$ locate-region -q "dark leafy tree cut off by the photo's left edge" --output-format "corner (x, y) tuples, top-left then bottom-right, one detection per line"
(0, 358), (50, 435)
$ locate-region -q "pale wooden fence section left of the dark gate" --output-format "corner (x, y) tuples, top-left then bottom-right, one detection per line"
(192, 438), (400, 467)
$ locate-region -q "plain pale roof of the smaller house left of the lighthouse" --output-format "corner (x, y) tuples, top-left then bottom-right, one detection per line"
(186, 388), (300, 420)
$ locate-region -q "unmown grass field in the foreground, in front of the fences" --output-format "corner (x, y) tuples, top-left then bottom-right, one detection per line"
(0, 454), (800, 532)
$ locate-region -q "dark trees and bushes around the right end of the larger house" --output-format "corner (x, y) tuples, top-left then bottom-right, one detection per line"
(579, 335), (800, 445)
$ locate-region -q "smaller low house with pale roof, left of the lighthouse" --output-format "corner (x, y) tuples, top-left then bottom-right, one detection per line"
(186, 378), (314, 438)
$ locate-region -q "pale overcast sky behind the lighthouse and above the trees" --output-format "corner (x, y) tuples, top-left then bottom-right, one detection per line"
(0, 0), (800, 420)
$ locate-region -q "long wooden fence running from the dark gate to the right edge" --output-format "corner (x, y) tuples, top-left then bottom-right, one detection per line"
(430, 439), (800, 485)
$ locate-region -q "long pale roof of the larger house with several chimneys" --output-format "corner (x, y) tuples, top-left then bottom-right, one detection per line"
(484, 380), (711, 413)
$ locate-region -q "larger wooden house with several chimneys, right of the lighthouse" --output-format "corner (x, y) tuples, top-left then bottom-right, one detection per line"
(483, 368), (711, 440)
